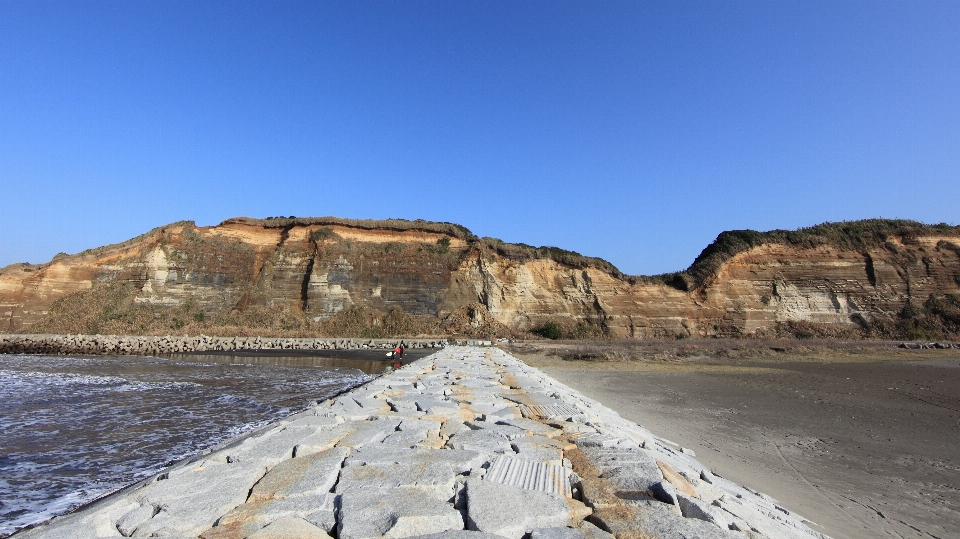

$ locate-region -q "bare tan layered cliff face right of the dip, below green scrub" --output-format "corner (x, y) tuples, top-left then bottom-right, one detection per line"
(692, 235), (960, 334)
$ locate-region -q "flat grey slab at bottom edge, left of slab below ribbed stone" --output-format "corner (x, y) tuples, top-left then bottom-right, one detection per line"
(337, 488), (463, 539)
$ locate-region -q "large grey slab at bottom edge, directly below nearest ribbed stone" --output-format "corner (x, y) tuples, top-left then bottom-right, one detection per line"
(466, 479), (590, 539)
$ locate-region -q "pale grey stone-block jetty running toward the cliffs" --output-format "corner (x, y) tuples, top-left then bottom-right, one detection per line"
(18, 346), (825, 539)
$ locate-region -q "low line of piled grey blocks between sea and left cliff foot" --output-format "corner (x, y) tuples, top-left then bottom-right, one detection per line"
(0, 335), (446, 355)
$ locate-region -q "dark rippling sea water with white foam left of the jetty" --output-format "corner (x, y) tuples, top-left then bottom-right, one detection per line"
(0, 355), (386, 537)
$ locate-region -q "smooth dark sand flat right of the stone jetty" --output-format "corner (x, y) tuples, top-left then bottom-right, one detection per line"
(527, 353), (960, 539)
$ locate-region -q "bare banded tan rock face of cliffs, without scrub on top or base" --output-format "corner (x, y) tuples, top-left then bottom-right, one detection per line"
(0, 218), (960, 338)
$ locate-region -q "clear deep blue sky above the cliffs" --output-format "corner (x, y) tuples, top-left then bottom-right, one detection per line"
(0, 0), (960, 274)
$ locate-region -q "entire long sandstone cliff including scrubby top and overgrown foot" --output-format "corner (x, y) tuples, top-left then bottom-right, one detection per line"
(0, 218), (960, 338)
